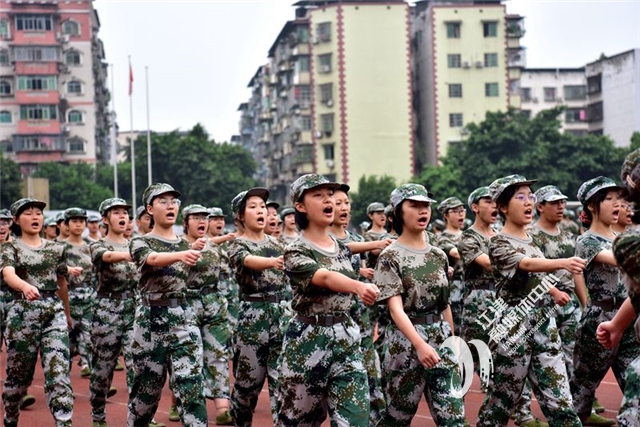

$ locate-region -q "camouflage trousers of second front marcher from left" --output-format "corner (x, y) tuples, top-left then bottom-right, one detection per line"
(89, 297), (137, 421)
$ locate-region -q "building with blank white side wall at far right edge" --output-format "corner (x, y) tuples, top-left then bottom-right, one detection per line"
(585, 49), (640, 147)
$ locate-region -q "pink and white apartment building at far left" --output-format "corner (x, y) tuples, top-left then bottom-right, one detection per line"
(0, 0), (110, 175)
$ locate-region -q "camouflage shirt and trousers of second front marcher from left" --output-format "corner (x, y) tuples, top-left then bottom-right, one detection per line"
(89, 237), (138, 421)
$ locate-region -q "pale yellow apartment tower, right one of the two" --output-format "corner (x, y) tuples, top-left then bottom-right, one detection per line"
(411, 0), (526, 167)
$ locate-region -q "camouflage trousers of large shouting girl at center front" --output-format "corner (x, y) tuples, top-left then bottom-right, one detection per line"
(276, 318), (369, 427)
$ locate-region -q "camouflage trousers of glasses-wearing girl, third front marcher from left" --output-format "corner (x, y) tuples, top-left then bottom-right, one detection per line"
(127, 303), (207, 427)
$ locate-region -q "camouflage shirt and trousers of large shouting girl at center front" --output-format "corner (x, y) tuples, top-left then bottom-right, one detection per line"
(276, 236), (370, 427)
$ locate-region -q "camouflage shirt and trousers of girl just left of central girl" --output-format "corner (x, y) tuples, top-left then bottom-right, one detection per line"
(229, 235), (291, 426)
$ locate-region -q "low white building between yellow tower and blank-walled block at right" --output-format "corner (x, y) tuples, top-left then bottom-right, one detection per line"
(520, 67), (589, 136)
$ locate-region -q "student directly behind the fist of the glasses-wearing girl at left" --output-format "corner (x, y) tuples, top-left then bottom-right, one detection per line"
(182, 205), (233, 425)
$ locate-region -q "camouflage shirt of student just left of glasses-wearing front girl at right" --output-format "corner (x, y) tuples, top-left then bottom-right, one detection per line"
(458, 227), (495, 289)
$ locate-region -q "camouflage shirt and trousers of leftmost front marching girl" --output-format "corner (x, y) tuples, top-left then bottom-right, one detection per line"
(1, 236), (73, 427)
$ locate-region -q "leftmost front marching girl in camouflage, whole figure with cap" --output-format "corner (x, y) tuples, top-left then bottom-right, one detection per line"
(0, 198), (73, 427)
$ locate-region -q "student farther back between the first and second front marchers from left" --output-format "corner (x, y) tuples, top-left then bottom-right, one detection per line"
(64, 208), (95, 377)
